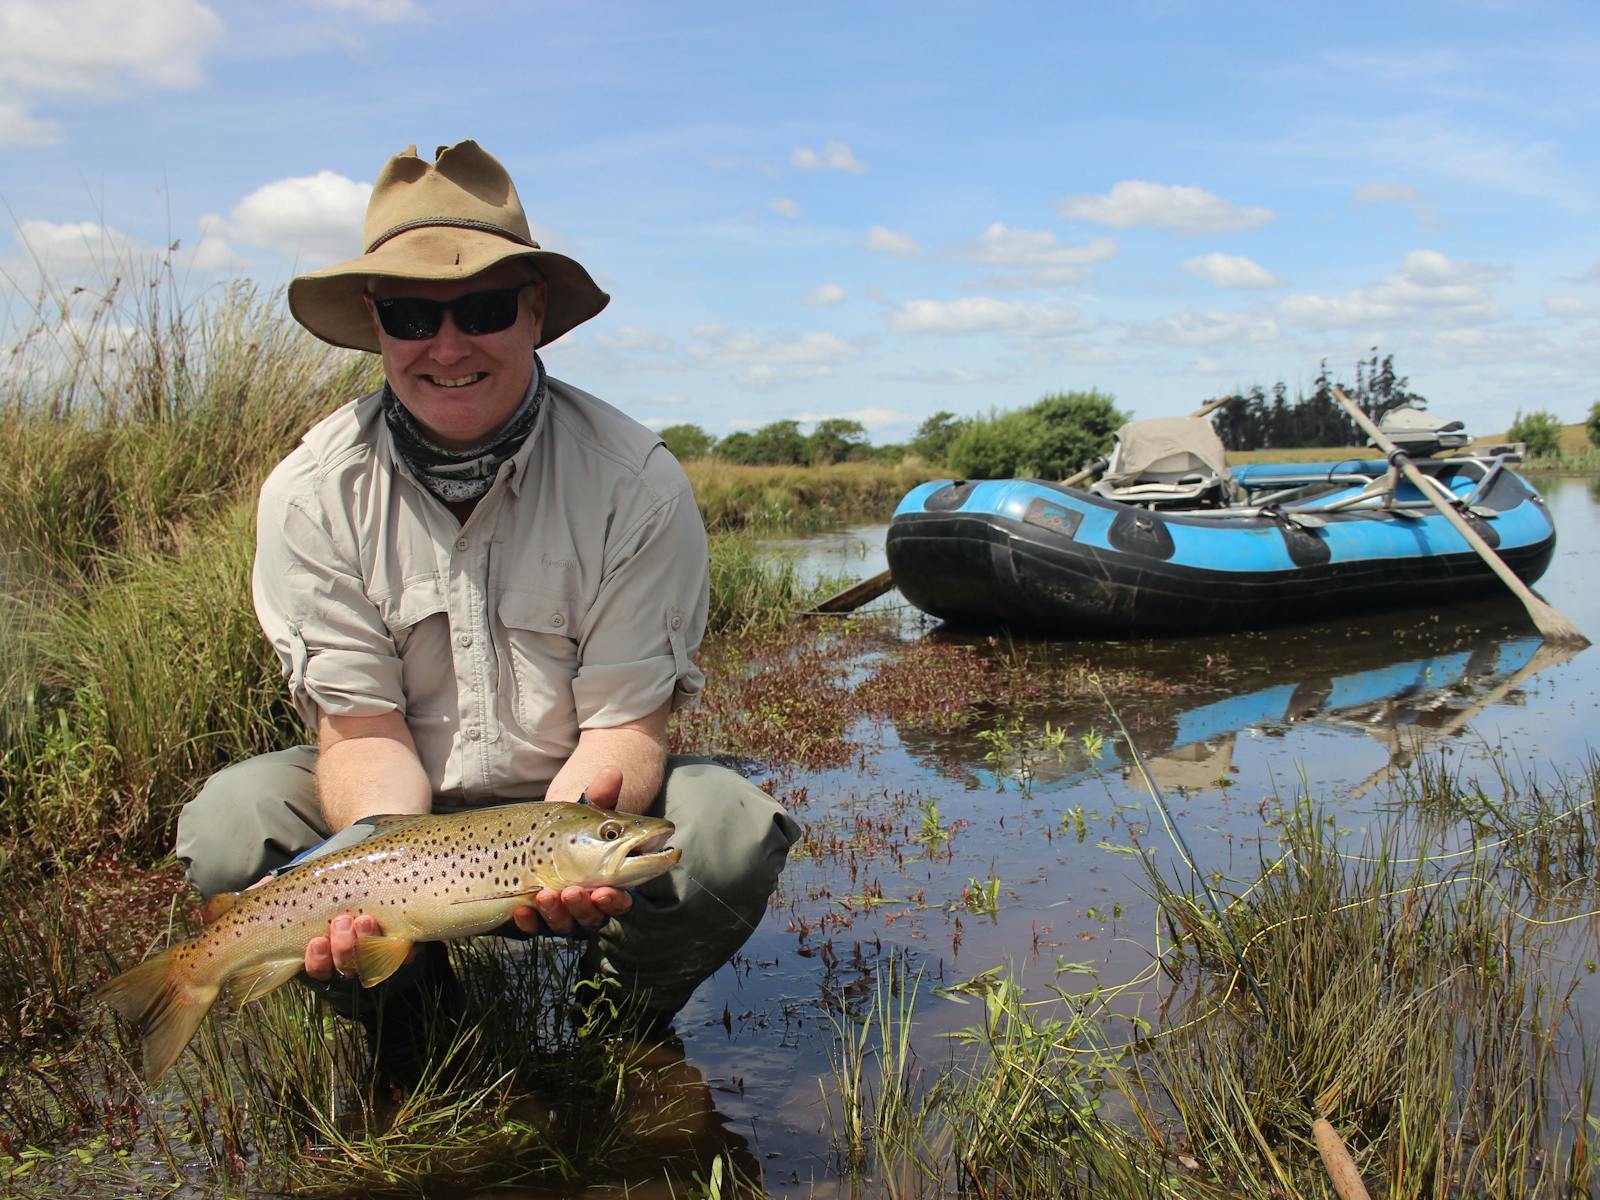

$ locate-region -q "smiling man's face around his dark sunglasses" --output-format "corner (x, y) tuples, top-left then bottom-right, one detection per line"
(366, 262), (546, 450)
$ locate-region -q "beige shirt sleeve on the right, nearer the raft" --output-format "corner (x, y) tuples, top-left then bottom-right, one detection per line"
(573, 448), (709, 730)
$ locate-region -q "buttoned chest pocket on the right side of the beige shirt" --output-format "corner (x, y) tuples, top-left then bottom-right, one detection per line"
(498, 589), (579, 746)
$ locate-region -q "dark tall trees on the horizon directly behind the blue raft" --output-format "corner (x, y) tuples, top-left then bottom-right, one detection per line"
(1211, 350), (1427, 450)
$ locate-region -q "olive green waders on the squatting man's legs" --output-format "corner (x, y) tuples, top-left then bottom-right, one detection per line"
(176, 746), (800, 1016)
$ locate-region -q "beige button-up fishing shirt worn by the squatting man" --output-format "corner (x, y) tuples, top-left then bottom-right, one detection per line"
(254, 379), (707, 800)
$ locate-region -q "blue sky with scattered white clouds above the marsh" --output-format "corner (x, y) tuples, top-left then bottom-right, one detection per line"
(0, 0), (1600, 443)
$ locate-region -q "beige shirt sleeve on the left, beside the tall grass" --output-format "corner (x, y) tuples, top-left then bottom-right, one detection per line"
(251, 469), (405, 726)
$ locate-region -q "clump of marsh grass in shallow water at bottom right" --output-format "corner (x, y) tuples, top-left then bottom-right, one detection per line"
(827, 763), (1600, 1200)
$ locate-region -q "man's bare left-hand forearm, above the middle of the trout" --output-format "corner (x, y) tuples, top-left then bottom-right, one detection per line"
(317, 712), (434, 832)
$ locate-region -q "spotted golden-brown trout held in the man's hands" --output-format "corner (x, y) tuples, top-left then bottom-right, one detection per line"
(94, 802), (682, 1083)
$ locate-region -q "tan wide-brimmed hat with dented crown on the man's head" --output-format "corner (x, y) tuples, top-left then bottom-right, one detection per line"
(290, 142), (611, 354)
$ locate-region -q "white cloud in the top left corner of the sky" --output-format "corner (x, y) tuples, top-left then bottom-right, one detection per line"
(0, 0), (222, 146)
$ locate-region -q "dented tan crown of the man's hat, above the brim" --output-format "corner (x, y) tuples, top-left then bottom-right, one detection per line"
(362, 141), (539, 254)
